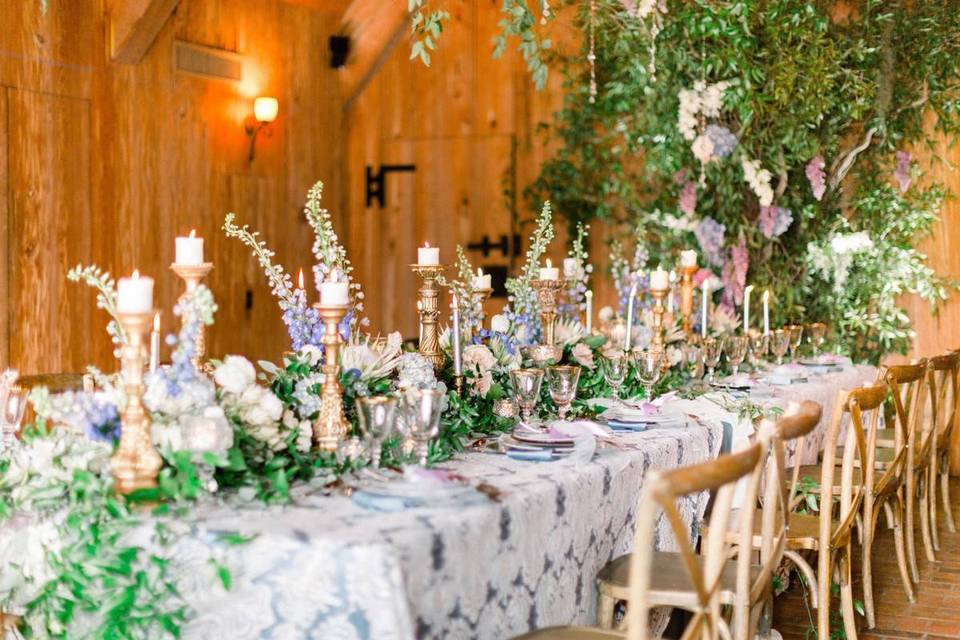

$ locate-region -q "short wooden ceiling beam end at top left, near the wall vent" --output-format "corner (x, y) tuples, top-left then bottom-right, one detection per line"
(107, 0), (180, 64)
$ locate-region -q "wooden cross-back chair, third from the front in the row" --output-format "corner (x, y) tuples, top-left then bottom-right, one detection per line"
(784, 382), (887, 640)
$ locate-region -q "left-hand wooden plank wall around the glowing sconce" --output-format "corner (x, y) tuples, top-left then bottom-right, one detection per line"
(0, 0), (345, 373)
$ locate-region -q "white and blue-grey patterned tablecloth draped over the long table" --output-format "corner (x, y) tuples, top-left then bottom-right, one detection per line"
(139, 366), (876, 640)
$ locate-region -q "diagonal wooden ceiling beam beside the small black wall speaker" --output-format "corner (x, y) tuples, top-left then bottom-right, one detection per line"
(339, 0), (409, 111)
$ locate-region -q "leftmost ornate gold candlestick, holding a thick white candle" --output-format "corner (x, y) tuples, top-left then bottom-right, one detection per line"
(110, 311), (163, 494)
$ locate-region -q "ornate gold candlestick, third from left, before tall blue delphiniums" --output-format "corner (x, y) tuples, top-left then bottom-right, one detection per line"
(313, 304), (350, 451)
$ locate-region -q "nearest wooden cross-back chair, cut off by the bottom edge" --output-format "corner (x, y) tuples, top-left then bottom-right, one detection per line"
(517, 443), (765, 640)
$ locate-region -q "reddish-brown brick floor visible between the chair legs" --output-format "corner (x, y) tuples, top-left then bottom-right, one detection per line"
(774, 478), (960, 640)
